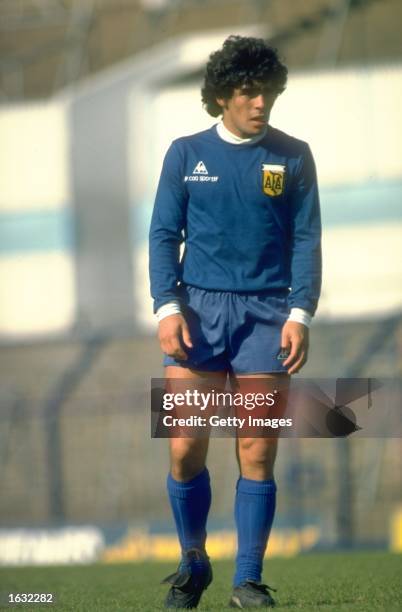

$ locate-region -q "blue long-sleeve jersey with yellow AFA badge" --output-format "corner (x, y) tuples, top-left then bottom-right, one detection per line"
(149, 126), (321, 314)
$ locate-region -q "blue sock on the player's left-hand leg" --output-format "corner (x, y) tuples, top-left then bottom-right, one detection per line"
(167, 468), (211, 552)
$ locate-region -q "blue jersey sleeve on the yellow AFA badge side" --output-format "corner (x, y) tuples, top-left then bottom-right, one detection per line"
(289, 144), (322, 315)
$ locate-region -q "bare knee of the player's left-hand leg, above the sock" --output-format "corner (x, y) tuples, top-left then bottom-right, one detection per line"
(170, 438), (208, 482)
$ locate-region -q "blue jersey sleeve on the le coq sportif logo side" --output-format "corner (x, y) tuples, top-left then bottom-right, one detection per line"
(149, 142), (187, 312)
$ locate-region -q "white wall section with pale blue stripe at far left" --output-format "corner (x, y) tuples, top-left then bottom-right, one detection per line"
(0, 102), (75, 337)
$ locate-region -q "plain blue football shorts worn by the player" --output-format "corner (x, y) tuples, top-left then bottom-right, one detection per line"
(164, 285), (289, 374)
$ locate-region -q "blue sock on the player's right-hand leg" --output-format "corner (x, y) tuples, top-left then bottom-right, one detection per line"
(233, 477), (276, 586)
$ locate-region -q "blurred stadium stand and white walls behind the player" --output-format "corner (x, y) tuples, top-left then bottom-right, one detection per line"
(0, 0), (402, 565)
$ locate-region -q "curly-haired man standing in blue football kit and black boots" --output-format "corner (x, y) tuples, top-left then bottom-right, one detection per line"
(150, 36), (321, 608)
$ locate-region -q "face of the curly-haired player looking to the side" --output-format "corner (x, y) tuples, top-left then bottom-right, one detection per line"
(217, 85), (279, 138)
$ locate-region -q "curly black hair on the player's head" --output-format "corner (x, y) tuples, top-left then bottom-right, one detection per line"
(201, 35), (288, 117)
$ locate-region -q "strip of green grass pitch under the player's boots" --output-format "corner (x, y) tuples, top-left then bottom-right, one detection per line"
(0, 552), (402, 612)
